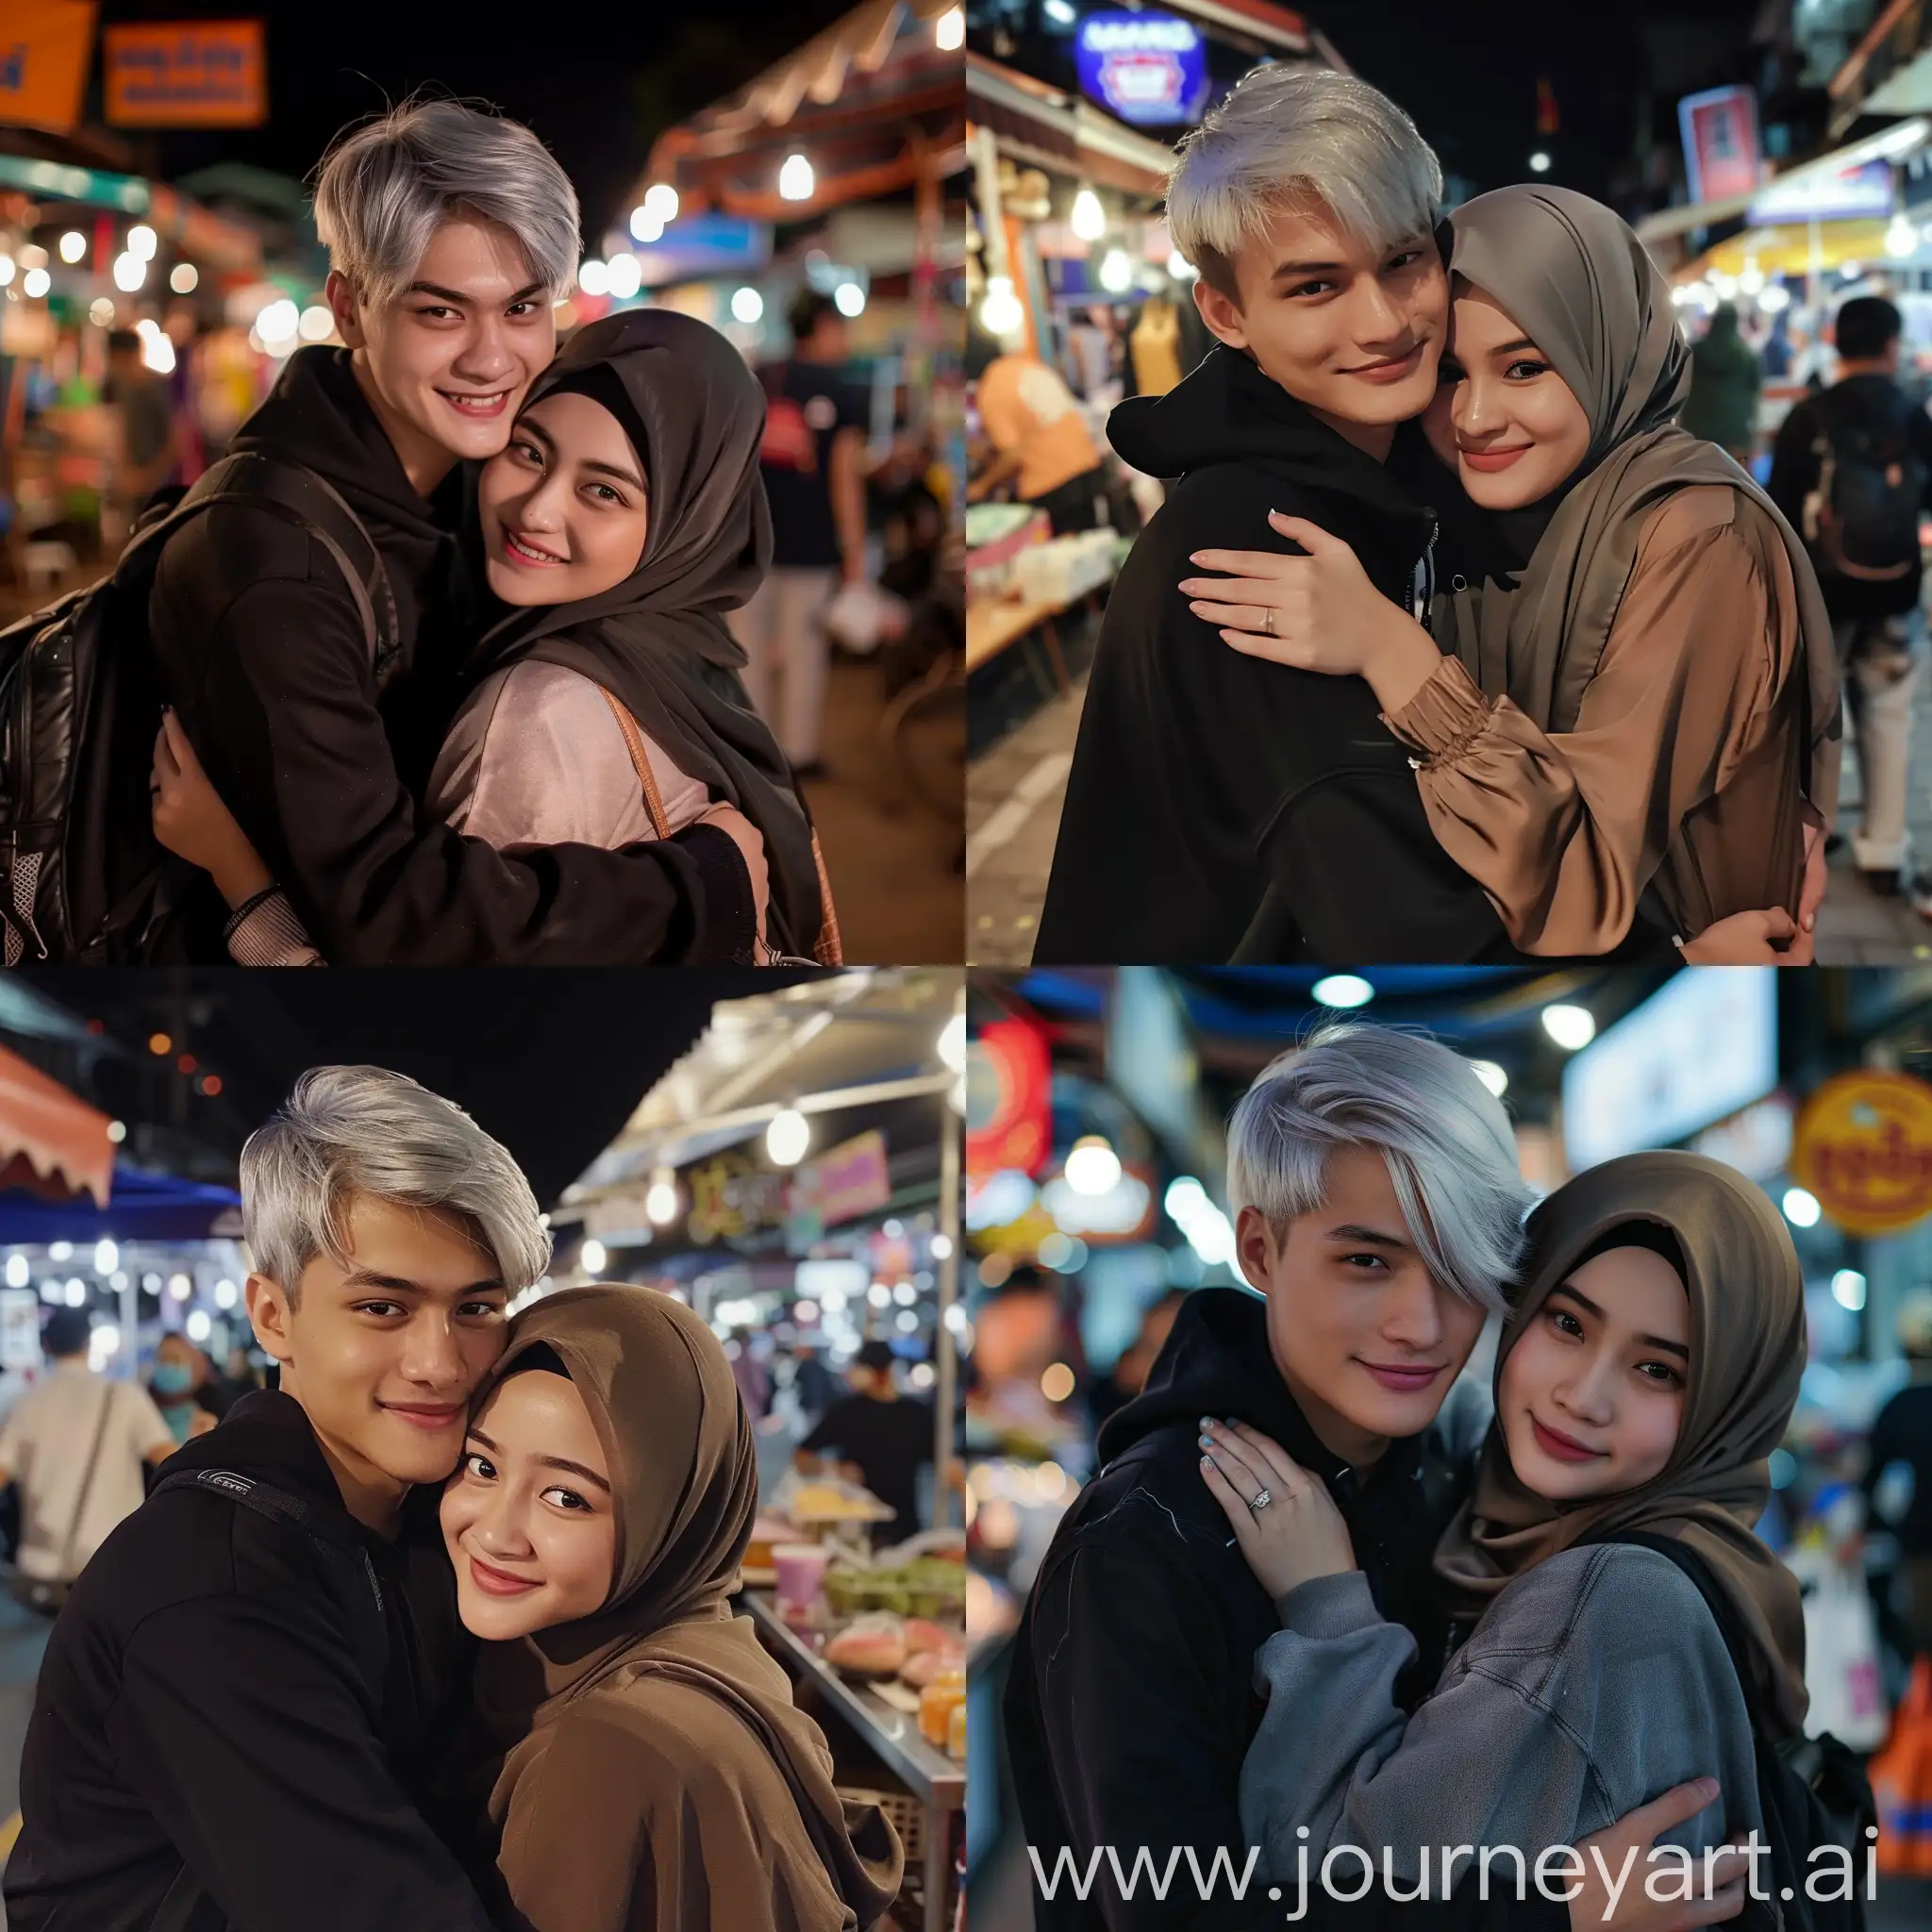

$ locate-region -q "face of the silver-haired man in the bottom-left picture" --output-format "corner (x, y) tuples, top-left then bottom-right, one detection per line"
(247, 1196), (508, 1490)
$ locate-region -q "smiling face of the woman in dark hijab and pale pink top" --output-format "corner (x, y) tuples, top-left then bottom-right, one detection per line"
(477, 391), (649, 605)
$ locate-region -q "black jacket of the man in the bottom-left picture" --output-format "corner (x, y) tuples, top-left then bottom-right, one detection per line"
(6, 1391), (491, 1932)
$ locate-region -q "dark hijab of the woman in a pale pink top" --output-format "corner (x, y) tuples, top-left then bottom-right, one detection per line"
(474, 309), (827, 957)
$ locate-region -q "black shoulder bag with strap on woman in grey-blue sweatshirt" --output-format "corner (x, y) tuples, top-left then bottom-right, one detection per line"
(1611, 1530), (1878, 1932)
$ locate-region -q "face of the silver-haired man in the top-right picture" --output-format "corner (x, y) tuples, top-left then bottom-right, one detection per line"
(1194, 207), (1449, 427)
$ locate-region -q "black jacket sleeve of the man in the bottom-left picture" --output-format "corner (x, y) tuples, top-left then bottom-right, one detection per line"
(107, 1594), (492, 1932)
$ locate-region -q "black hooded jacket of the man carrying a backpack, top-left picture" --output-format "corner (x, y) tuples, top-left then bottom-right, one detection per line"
(149, 348), (752, 966)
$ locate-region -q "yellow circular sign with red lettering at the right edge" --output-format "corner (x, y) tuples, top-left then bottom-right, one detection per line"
(1790, 1071), (1932, 1235)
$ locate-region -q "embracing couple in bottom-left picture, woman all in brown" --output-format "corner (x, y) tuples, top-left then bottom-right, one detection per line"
(6, 1066), (902, 1932)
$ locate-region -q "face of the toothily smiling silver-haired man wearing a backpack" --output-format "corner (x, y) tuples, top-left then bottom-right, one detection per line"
(328, 214), (557, 473)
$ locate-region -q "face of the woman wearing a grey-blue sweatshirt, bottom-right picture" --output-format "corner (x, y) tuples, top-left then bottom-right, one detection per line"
(1497, 1248), (1690, 1503)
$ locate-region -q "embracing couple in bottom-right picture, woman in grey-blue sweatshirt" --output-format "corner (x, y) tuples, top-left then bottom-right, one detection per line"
(1007, 1024), (1866, 1932)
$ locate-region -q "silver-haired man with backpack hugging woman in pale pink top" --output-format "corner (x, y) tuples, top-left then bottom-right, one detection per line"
(149, 100), (763, 966)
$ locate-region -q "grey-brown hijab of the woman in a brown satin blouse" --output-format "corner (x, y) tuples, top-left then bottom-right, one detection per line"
(1436, 188), (1840, 823)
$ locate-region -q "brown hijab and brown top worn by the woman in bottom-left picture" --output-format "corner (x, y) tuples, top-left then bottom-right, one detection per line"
(461, 1287), (904, 1932)
